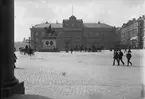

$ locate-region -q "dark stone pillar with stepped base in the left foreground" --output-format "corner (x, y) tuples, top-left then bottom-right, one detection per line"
(0, 0), (24, 97)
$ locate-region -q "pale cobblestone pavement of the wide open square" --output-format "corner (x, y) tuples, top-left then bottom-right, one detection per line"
(15, 51), (144, 99)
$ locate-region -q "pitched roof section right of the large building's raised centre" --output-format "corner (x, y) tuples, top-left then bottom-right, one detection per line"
(84, 23), (113, 28)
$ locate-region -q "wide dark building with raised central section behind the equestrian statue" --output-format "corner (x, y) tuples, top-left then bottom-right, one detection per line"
(30, 15), (116, 51)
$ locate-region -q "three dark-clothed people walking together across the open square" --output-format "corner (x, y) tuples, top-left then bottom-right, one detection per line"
(113, 49), (132, 66)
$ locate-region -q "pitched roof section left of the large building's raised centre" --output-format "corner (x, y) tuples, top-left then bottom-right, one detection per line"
(34, 23), (63, 28)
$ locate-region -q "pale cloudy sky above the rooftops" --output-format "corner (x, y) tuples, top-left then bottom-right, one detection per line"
(15, 0), (145, 41)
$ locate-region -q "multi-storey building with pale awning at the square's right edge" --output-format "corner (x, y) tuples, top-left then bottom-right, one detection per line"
(121, 16), (145, 49)
